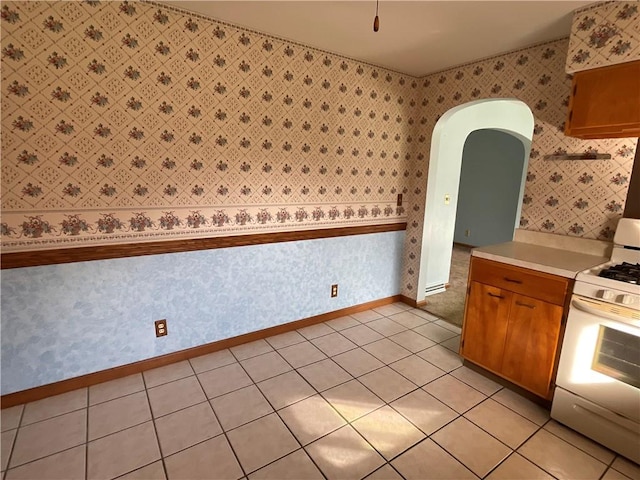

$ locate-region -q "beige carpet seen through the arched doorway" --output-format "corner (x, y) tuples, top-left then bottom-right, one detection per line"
(422, 245), (471, 327)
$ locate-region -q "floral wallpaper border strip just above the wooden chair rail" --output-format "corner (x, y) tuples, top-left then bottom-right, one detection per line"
(0, 202), (406, 253)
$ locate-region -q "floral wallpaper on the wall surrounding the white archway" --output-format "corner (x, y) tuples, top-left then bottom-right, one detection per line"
(402, 39), (637, 299)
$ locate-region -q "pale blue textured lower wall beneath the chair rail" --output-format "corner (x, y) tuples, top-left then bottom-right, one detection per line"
(2, 231), (404, 395)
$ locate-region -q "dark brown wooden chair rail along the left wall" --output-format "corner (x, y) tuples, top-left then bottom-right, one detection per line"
(0, 222), (407, 270)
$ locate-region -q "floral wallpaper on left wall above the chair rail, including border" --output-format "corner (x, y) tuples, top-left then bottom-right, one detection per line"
(1, 1), (424, 251)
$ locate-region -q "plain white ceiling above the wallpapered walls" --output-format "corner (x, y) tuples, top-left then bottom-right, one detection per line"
(160, 0), (593, 77)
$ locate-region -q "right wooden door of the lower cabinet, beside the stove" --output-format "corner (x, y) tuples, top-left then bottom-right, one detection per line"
(502, 294), (563, 398)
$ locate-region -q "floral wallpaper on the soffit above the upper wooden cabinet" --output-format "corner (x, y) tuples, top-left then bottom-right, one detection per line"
(565, 1), (640, 73)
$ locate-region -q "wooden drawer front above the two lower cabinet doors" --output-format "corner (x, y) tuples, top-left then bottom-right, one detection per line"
(470, 257), (569, 305)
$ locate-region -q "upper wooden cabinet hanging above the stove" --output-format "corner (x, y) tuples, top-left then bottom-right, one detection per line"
(564, 60), (640, 139)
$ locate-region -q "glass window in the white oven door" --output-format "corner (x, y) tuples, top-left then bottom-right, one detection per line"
(591, 325), (640, 388)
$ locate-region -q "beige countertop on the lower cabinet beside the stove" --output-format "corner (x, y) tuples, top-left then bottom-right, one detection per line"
(471, 242), (609, 278)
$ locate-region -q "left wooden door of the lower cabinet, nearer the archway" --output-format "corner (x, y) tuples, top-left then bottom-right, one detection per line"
(460, 282), (513, 373)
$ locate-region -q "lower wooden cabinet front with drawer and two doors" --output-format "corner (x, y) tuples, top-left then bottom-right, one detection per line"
(460, 257), (570, 399)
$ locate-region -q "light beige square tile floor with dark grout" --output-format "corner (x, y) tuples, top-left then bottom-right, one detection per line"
(1, 304), (640, 480)
